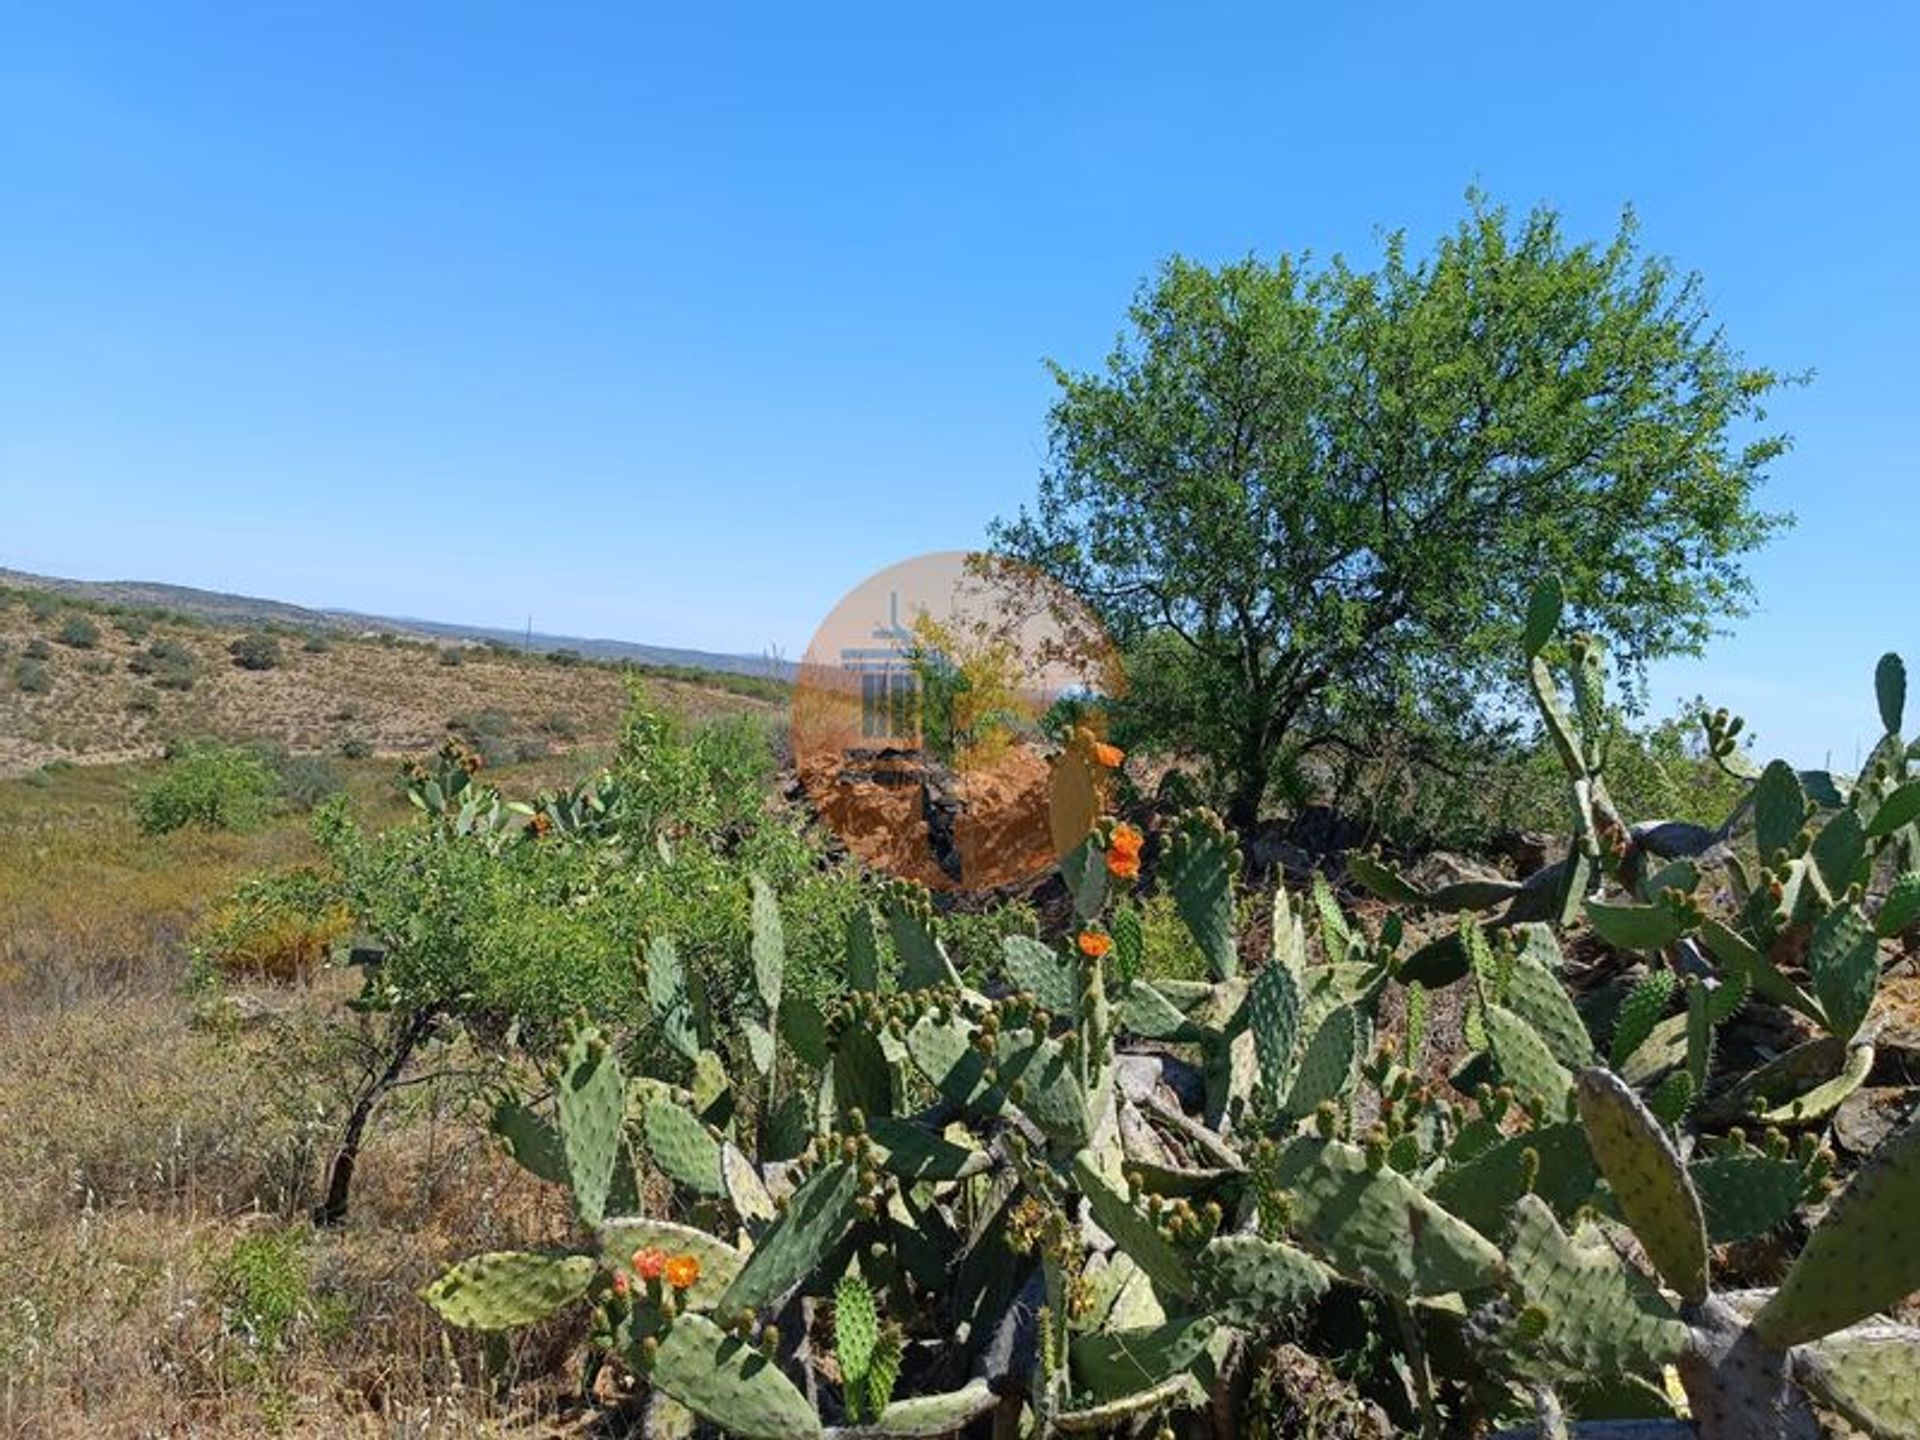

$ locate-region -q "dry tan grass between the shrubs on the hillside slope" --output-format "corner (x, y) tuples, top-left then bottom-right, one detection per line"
(0, 605), (768, 791)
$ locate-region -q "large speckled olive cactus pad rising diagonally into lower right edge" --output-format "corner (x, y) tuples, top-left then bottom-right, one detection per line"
(1753, 1119), (1920, 1348)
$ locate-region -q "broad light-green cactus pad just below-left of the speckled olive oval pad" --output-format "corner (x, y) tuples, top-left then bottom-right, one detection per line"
(1507, 1194), (1688, 1380)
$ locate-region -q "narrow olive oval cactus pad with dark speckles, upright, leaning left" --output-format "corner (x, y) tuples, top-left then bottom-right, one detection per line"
(1576, 1068), (1707, 1304)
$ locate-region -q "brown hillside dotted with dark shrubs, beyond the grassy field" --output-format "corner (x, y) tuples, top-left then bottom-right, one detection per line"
(0, 589), (778, 776)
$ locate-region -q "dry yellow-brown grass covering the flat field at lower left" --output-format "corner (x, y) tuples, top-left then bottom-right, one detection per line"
(0, 737), (748, 1440)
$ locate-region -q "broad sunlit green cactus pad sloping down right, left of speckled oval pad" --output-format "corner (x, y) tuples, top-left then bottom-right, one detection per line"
(1275, 1137), (1501, 1298)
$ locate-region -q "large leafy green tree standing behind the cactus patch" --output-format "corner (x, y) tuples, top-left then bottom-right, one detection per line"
(995, 198), (1786, 826)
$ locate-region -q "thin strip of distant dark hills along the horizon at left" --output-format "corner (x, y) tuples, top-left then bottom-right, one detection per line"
(0, 568), (793, 680)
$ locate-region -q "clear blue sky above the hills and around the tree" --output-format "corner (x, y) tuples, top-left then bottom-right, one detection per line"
(0, 0), (1920, 764)
